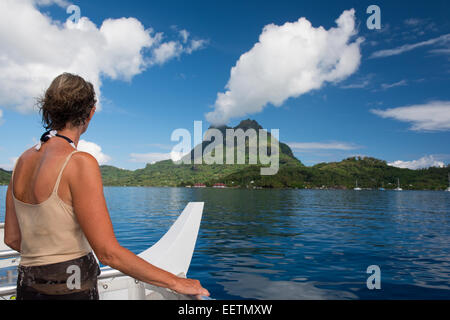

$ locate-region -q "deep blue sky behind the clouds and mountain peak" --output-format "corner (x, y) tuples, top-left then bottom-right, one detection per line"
(0, 0), (450, 169)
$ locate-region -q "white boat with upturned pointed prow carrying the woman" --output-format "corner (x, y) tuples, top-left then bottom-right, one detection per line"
(0, 202), (208, 300)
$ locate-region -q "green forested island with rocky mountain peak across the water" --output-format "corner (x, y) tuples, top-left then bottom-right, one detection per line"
(0, 120), (450, 190)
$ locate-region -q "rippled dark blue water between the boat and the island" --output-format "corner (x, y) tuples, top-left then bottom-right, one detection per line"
(0, 187), (450, 299)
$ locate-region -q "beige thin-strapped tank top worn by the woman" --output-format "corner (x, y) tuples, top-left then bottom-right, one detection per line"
(12, 151), (92, 267)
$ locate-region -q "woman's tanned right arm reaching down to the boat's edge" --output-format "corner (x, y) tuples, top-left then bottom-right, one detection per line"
(67, 153), (209, 296)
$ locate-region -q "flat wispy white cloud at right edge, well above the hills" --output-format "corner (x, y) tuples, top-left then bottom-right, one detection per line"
(371, 101), (450, 131)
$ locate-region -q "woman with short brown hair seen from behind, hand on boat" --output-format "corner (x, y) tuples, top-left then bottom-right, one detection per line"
(4, 73), (209, 300)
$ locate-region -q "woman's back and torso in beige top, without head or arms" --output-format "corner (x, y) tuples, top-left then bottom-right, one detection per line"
(12, 138), (91, 266)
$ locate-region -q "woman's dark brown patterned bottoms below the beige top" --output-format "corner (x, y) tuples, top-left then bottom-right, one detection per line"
(17, 253), (100, 300)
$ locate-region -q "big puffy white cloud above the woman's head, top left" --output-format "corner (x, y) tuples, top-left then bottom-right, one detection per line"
(0, 0), (206, 112)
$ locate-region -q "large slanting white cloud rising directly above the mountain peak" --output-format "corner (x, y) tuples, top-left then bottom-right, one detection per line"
(206, 9), (363, 125)
